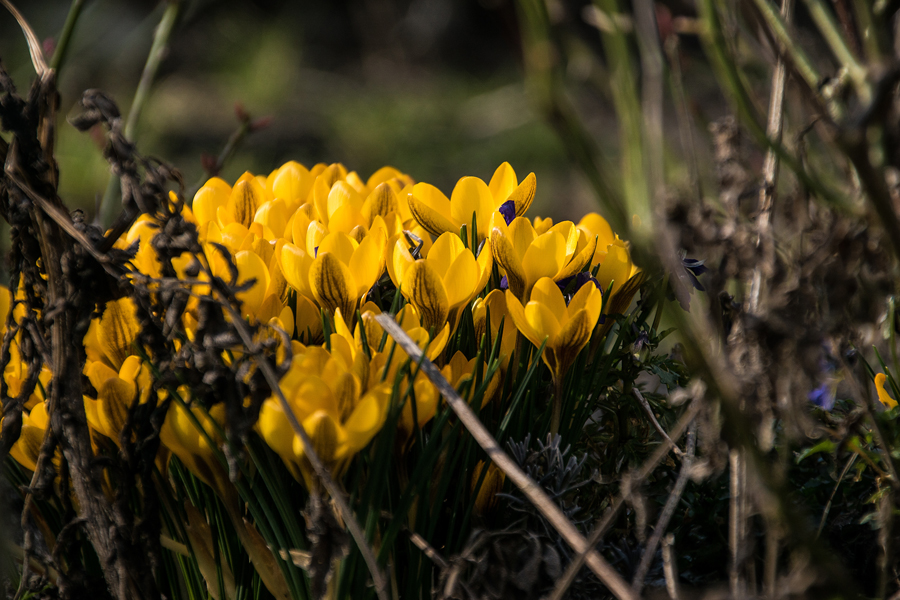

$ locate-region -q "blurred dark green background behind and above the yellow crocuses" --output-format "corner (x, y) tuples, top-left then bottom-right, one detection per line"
(0, 0), (615, 219)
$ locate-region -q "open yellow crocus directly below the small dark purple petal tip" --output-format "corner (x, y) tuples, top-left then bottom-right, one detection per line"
(491, 217), (597, 300)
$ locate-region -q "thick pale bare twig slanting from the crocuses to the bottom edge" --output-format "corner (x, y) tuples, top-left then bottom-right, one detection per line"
(375, 314), (637, 600)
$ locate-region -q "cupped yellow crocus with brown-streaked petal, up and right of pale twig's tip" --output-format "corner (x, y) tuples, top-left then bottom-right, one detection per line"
(392, 232), (492, 331)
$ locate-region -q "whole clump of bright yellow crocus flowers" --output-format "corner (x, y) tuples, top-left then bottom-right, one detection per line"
(0, 161), (641, 490)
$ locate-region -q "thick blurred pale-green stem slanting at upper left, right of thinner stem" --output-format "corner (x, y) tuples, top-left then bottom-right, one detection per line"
(100, 0), (181, 226)
